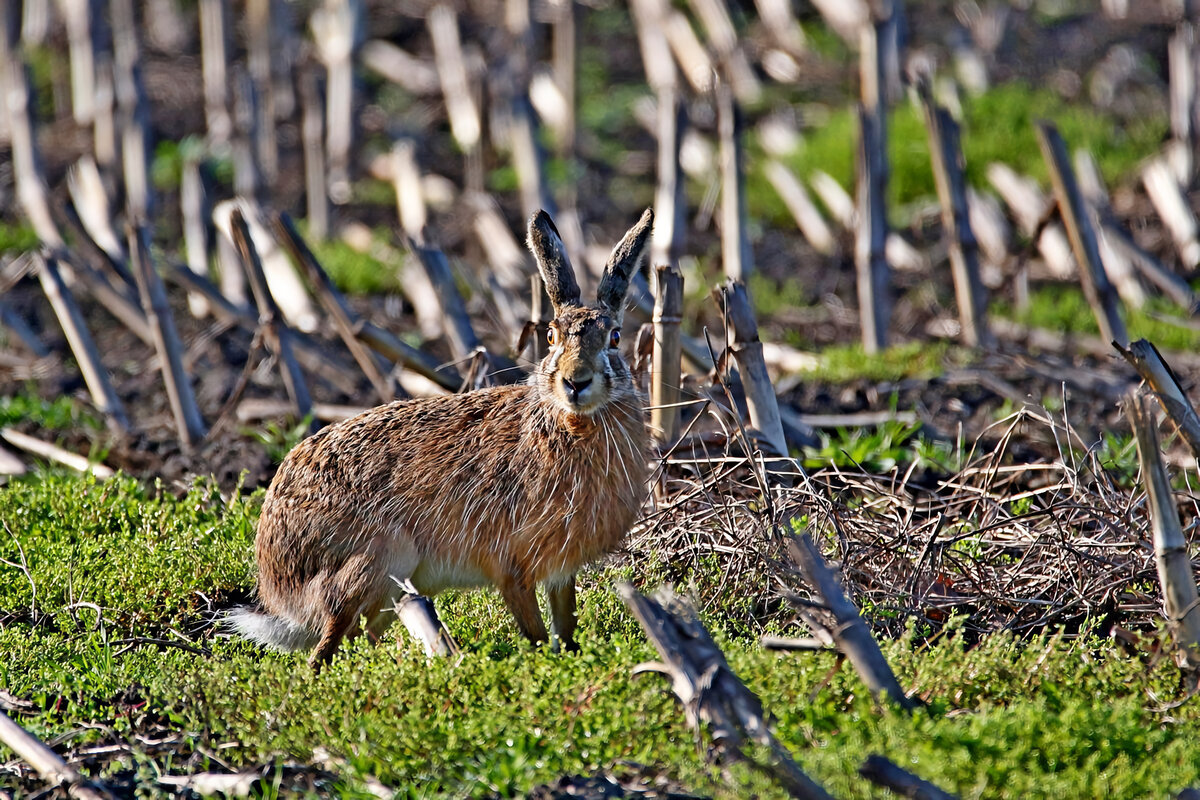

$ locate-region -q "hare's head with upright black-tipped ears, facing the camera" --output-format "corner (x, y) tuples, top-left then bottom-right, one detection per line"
(529, 209), (654, 415)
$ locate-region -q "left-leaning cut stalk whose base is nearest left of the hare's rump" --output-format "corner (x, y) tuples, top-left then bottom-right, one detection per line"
(128, 225), (206, 452)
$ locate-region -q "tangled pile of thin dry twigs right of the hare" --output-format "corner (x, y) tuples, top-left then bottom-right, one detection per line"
(630, 408), (1176, 636)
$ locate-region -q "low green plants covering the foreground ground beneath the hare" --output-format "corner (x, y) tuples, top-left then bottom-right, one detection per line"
(0, 475), (1200, 798)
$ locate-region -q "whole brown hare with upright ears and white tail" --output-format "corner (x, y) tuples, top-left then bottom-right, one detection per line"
(229, 210), (654, 666)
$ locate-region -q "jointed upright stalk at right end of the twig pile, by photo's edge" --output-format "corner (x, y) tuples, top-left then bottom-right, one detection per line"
(1124, 393), (1200, 670)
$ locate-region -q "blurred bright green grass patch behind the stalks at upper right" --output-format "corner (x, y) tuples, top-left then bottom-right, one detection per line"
(746, 83), (1168, 222)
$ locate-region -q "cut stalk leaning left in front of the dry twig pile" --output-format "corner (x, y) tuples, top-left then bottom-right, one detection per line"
(787, 533), (918, 711)
